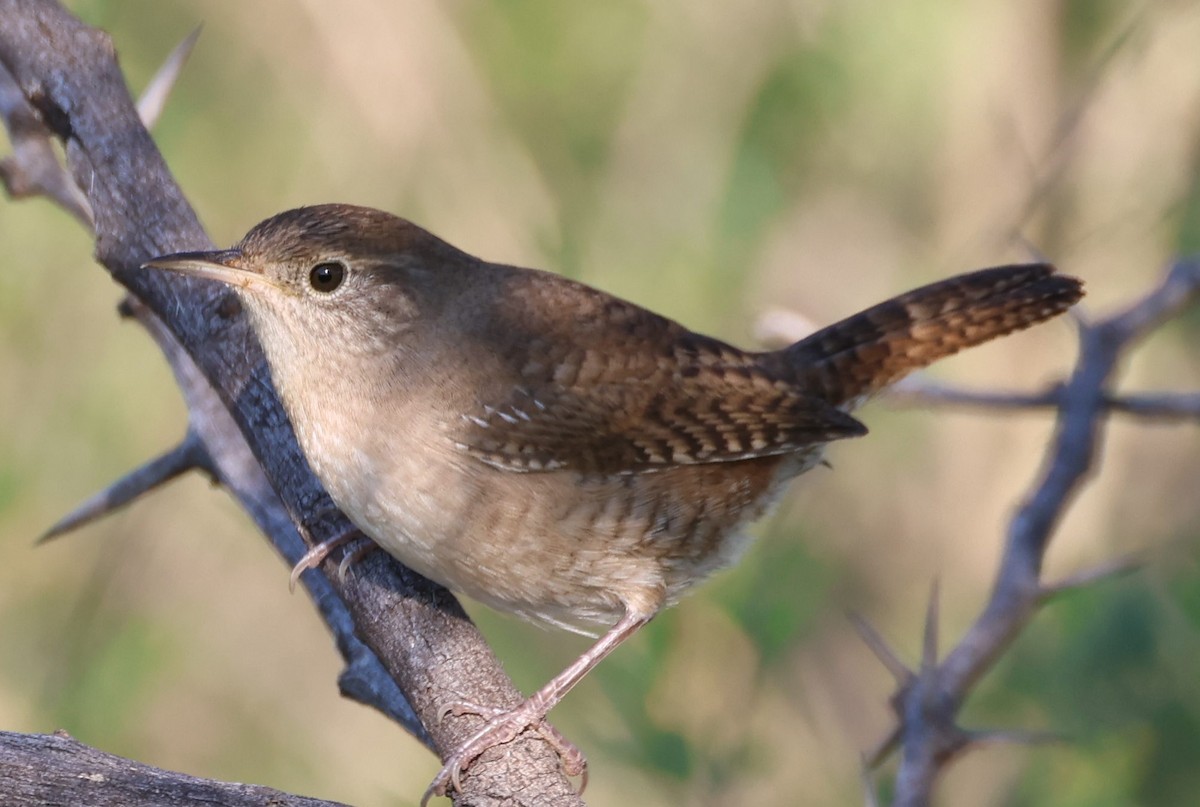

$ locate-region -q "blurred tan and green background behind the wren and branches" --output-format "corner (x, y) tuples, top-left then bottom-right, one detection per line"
(0, 0), (1200, 806)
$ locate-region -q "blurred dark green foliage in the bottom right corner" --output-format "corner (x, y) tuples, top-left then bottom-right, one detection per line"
(972, 566), (1200, 807)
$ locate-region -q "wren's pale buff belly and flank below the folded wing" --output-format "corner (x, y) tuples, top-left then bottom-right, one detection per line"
(301, 396), (815, 629)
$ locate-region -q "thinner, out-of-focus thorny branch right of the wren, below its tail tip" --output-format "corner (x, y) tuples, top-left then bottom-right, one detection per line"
(757, 264), (1200, 807)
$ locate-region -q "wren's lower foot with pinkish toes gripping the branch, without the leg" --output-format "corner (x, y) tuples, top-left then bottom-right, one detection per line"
(421, 698), (588, 807)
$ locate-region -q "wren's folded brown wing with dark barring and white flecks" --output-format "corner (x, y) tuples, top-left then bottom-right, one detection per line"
(460, 367), (866, 473)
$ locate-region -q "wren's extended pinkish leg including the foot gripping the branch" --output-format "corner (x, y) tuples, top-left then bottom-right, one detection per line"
(421, 611), (653, 807)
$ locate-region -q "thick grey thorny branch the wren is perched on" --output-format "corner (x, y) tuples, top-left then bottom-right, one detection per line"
(0, 0), (581, 805)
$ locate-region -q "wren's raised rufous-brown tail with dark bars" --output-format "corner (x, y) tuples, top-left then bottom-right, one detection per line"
(779, 263), (1084, 407)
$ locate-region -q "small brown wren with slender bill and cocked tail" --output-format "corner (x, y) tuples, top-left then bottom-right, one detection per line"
(146, 204), (1082, 799)
